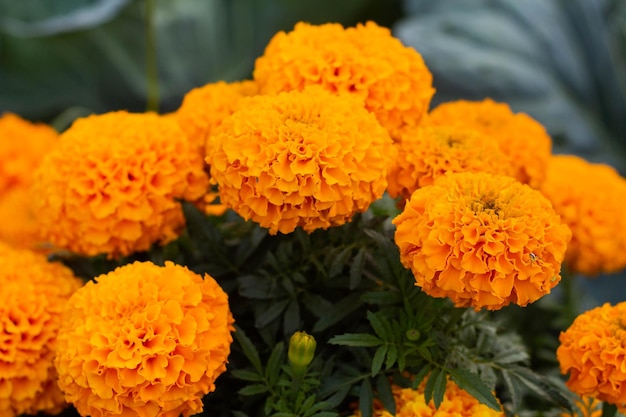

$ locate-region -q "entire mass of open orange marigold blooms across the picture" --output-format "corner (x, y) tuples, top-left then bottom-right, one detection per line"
(0, 22), (626, 417)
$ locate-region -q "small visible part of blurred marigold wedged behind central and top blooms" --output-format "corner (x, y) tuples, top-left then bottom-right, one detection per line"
(174, 81), (258, 154)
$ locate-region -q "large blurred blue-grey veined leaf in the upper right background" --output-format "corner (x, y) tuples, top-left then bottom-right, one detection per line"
(394, 0), (626, 168)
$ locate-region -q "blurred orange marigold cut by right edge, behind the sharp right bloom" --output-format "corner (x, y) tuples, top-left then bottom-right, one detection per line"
(540, 155), (626, 276)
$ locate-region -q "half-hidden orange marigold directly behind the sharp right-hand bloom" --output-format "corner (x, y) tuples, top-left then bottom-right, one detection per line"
(387, 126), (512, 200)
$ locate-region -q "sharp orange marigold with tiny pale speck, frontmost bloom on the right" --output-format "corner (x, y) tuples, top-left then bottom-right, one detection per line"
(393, 173), (571, 310)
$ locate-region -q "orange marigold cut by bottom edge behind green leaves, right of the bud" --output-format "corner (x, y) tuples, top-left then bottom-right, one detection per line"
(354, 380), (504, 417)
